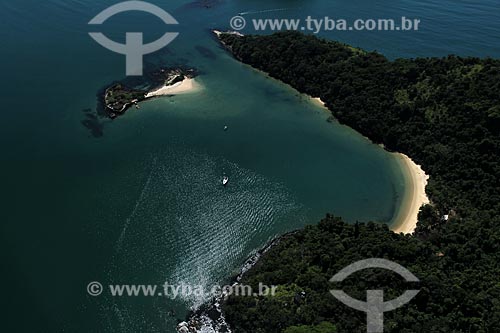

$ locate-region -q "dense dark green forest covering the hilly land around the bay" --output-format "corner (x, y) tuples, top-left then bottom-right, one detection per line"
(220, 32), (500, 333)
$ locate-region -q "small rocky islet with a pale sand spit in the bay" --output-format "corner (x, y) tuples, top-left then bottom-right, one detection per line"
(102, 69), (196, 119)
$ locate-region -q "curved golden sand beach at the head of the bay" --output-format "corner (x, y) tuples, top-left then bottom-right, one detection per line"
(391, 153), (429, 234)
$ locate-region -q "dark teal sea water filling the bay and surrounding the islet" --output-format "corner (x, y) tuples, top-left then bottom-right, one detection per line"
(0, 0), (500, 332)
